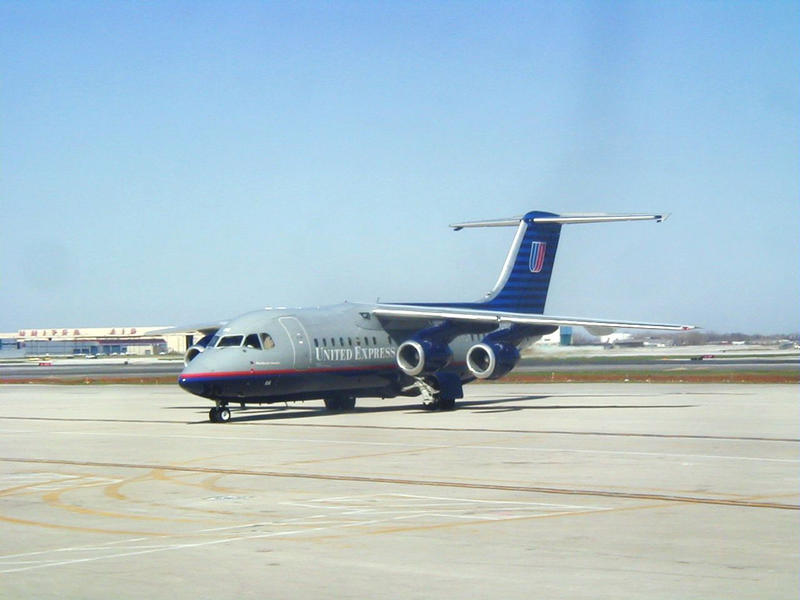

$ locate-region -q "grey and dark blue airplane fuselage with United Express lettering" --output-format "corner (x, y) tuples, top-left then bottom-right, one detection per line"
(178, 303), (520, 404)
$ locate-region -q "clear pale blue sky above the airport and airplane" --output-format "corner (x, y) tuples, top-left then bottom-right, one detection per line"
(0, 1), (800, 333)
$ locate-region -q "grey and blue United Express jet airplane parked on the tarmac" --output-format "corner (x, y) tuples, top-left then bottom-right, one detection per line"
(173, 211), (694, 423)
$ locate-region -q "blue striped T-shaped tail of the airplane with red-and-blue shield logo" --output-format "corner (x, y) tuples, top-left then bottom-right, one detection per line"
(451, 211), (666, 314)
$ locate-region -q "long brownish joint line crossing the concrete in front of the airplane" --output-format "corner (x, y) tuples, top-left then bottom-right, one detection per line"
(0, 457), (800, 510)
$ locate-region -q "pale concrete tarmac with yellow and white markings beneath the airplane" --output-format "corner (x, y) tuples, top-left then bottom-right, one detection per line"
(0, 384), (800, 600)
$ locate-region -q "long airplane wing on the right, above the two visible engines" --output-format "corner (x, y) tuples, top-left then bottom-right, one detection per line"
(372, 304), (695, 335)
